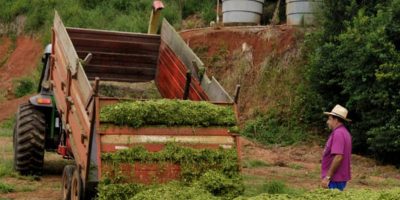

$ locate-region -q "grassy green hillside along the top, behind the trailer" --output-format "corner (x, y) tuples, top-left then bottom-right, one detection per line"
(0, 0), (216, 42)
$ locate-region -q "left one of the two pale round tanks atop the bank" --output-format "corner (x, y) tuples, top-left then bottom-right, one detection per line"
(222, 0), (265, 24)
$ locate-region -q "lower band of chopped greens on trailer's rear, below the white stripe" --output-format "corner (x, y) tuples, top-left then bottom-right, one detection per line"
(101, 143), (239, 183)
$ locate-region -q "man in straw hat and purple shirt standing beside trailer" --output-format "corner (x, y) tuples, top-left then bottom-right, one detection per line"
(321, 105), (351, 191)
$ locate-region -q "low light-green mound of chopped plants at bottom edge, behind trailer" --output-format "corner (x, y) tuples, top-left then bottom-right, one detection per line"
(130, 182), (219, 200)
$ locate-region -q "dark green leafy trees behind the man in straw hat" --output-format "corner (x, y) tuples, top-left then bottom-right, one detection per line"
(298, 0), (400, 164)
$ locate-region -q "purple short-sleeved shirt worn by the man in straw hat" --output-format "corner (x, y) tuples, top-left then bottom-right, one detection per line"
(321, 125), (351, 182)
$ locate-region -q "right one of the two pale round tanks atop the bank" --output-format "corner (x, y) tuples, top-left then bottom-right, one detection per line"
(286, 0), (322, 26)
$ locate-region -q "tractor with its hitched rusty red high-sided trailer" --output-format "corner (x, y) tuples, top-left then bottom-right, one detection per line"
(14, 12), (240, 199)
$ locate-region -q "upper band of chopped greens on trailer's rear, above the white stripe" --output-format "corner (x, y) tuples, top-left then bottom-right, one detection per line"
(100, 99), (236, 128)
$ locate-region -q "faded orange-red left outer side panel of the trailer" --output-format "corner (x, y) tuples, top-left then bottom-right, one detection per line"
(50, 12), (92, 181)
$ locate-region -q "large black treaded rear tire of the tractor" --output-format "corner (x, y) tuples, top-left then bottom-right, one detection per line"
(13, 103), (46, 175)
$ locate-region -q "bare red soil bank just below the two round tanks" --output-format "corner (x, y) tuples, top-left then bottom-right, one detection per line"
(180, 26), (295, 65)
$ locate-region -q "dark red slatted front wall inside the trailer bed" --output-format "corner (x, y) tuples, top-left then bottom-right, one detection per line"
(67, 28), (161, 82)
